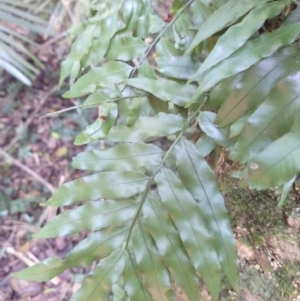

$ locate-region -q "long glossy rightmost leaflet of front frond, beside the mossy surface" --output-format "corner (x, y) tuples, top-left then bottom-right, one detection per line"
(175, 140), (237, 289)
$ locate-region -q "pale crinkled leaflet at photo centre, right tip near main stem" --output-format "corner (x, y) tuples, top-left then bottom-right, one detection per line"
(106, 113), (185, 142)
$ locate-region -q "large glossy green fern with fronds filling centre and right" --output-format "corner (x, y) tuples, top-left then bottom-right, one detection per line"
(15, 0), (300, 301)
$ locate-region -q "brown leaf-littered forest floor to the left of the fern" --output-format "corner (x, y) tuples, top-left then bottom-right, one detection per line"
(0, 35), (97, 301)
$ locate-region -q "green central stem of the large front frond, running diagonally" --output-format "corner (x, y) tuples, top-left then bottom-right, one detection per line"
(125, 96), (209, 248)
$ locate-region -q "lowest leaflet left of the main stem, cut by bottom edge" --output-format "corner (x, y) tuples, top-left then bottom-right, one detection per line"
(71, 248), (124, 301)
